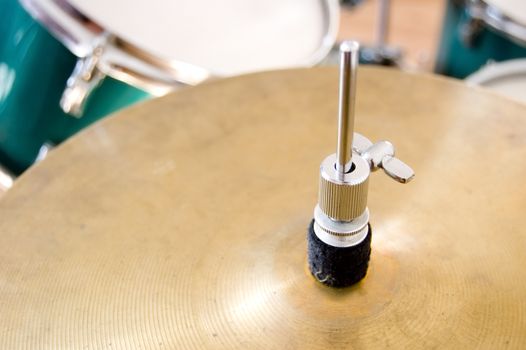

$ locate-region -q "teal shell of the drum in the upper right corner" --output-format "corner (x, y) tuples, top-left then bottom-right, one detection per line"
(435, 0), (526, 78)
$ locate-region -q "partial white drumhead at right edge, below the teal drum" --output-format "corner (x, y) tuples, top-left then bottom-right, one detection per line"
(466, 59), (526, 103)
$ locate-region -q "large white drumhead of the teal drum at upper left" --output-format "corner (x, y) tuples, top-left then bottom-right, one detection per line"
(70, 0), (338, 75)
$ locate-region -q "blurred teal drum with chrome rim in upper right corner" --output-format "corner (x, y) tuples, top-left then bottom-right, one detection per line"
(435, 0), (526, 78)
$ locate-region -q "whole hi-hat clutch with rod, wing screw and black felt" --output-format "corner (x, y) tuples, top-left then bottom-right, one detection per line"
(307, 41), (414, 287)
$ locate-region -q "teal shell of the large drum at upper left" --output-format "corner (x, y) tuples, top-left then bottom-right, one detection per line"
(0, 0), (150, 174)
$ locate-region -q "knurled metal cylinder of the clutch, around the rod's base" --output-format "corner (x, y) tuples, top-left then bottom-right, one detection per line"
(318, 154), (371, 221)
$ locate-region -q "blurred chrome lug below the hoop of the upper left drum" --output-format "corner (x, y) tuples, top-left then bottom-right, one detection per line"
(60, 44), (106, 118)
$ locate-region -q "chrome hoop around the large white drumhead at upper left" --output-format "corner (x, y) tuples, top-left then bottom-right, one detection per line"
(19, 0), (339, 96)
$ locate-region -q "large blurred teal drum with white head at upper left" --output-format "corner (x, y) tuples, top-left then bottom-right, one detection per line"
(0, 0), (339, 173)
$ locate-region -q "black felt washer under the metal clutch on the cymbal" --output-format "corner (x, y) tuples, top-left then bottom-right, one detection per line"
(307, 220), (372, 287)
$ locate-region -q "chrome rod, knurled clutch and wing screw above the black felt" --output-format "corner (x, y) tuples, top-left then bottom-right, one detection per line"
(313, 41), (415, 247)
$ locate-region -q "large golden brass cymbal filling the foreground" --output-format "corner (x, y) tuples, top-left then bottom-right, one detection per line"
(0, 68), (526, 349)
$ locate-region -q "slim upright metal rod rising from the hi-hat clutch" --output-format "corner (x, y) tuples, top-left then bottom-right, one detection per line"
(336, 41), (360, 176)
